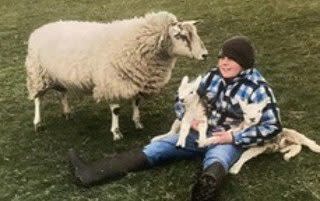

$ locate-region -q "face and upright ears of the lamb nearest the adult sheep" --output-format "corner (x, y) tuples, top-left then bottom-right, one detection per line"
(178, 76), (201, 105)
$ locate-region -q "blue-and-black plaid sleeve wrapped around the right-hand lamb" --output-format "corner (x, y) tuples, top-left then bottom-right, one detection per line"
(234, 85), (282, 147)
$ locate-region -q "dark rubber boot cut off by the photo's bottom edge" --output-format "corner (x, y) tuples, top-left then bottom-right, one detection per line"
(191, 162), (226, 201)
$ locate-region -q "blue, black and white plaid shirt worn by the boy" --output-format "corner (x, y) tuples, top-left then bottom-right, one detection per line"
(175, 68), (282, 147)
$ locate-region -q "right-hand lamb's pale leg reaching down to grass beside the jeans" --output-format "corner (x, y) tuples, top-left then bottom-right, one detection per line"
(229, 146), (268, 174)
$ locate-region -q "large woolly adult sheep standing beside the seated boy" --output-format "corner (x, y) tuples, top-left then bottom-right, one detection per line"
(26, 11), (208, 140)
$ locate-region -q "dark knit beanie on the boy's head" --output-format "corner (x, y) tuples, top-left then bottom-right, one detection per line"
(218, 36), (255, 69)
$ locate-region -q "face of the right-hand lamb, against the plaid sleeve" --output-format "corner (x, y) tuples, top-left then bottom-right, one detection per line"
(239, 100), (269, 126)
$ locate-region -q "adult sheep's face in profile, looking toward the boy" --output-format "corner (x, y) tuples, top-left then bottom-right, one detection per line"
(169, 21), (208, 60)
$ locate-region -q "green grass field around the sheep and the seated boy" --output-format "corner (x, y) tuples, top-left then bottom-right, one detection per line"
(0, 0), (320, 201)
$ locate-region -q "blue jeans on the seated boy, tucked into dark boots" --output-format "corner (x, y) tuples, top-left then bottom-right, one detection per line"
(143, 131), (244, 172)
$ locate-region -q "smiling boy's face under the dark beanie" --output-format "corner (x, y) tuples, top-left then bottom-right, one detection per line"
(218, 57), (243, 78)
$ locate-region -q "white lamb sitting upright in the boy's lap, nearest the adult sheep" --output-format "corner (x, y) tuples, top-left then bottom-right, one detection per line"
(151, 76), (208, 148)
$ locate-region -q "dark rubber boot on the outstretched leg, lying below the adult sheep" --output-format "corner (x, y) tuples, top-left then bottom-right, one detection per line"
(68, 149), (149, 187)
